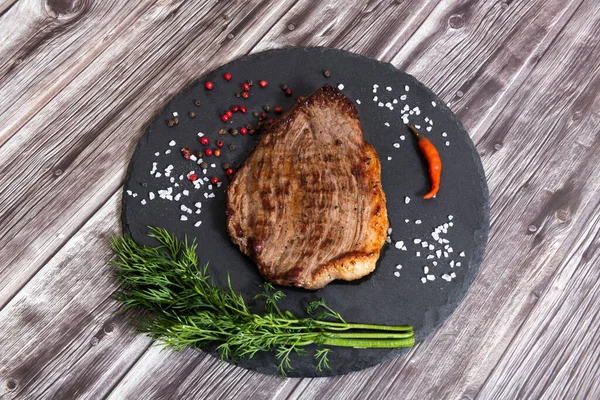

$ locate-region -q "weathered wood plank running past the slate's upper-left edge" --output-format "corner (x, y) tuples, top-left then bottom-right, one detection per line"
(0, 2), (292, 305)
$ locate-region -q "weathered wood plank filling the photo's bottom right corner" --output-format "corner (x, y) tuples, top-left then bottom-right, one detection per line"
(479, 198), (600, 399)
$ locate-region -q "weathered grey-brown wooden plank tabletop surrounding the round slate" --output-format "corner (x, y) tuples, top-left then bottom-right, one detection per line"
(0, 0), (600, 399)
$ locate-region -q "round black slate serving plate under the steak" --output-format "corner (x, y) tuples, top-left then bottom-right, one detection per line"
(122, 48), (489, 376)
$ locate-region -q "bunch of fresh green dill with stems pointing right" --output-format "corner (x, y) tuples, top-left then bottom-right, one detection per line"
(112, 228), (414, 376)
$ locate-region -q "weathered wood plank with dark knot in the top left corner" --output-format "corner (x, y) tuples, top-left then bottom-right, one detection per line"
(0, 0), (157, 145)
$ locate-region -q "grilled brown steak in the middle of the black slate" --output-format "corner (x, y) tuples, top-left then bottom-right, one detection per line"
(227, 85), (389, 289)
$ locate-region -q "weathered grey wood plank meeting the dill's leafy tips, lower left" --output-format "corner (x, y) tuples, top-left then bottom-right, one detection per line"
(0, 195), (150, 399)
